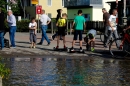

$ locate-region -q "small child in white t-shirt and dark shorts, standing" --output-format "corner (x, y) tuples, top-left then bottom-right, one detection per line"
(29, 17), (37, 48)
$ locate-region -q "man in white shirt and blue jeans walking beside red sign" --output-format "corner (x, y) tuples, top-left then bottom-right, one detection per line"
(38, 10), (51, 45)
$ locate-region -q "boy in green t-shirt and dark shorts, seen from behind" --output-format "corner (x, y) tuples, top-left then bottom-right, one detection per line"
(71, 10), (85, 50)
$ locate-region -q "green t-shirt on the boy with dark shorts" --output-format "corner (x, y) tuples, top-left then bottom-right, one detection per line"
(74, 15), (85, 30)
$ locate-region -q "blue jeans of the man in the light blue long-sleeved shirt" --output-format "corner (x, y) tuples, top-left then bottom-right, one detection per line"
(9, 26), (16, 47)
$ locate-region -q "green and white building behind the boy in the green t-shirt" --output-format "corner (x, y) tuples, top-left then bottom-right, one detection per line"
(64, 0), (121, 21)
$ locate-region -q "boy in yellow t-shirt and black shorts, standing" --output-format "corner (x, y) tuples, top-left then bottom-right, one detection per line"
(56, 13), (67, 49)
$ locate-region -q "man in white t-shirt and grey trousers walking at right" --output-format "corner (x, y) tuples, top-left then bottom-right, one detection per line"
(104, 9), (119, 47)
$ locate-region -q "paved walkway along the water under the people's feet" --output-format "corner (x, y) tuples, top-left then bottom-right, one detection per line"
(0, 32), (108, 57)
